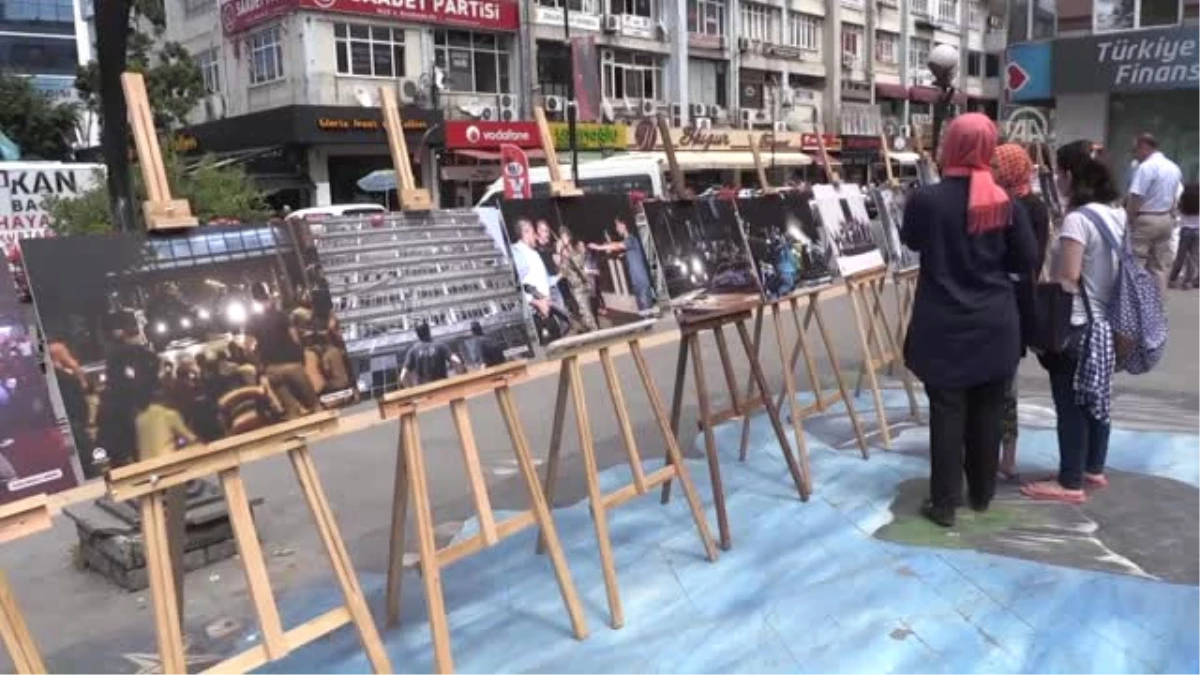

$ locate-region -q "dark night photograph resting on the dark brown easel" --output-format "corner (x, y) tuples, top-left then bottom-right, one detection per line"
(643, 197), (762, 319)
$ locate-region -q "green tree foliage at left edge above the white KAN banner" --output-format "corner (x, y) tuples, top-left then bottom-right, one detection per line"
(0, 73), (79, 160)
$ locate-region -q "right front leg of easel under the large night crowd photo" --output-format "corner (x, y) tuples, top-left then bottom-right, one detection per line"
(288, 446), (391, 675)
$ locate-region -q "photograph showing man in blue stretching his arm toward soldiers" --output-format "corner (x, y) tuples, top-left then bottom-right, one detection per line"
(500, 195), (659, 345)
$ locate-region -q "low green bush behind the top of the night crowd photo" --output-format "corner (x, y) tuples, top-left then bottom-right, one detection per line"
(43, 153), (270, 234)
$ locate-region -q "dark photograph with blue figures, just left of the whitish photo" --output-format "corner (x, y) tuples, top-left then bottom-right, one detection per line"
(738, 190), (832, 299)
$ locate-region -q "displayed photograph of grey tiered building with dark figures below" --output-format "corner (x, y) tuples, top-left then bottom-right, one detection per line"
(296, 209), (533, 398)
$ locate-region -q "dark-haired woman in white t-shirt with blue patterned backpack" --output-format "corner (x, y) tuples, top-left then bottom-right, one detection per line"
(1021, 141), (1126, 504)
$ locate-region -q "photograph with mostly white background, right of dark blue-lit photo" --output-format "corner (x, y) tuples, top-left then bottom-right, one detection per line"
(812, 183), (883, 277)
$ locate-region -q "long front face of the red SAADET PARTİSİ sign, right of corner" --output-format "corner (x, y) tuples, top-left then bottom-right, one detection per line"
(300, 0), (520, 30)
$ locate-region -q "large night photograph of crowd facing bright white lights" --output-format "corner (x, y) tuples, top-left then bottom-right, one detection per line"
(22, 225), (358, 478)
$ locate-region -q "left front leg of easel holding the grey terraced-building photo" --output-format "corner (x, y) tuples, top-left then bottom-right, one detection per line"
(400, 414), (454, 675)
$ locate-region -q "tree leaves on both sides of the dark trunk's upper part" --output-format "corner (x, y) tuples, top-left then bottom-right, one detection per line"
(76, 0), (206, 130)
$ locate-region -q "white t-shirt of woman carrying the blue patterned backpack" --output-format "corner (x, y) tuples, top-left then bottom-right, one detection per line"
(1055, 203), (1126, 325)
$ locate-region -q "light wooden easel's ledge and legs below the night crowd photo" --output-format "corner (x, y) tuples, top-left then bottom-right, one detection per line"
(106, 412), (392, 675)
